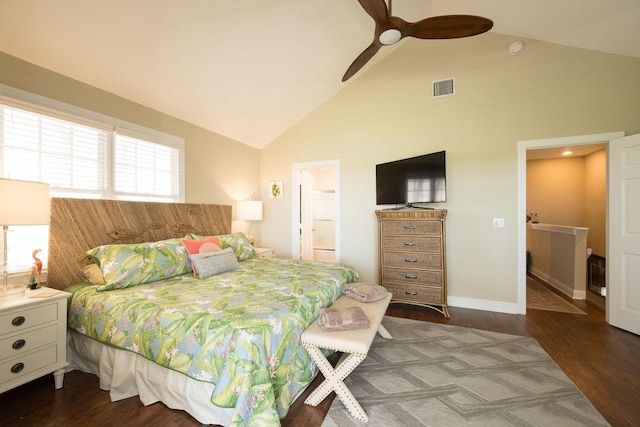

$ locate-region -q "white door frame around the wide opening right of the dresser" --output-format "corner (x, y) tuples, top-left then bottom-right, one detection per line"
(516, 131), (625, 314)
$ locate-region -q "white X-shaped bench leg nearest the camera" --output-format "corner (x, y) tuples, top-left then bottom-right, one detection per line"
(304, 344), (369, 422)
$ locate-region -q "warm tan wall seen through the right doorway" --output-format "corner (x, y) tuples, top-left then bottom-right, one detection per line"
(527, 150), (607, 256)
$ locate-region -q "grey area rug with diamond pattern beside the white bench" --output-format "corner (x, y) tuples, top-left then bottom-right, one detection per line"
(322, 316), (609, 427)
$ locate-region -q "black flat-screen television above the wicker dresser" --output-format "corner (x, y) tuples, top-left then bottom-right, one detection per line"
(376, 151), (447, 206)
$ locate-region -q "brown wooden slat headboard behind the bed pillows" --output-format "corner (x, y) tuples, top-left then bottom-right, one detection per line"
(47, 198), (231, 289)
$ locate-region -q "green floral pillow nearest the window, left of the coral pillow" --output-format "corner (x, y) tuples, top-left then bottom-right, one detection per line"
(87, 239), (191, 291)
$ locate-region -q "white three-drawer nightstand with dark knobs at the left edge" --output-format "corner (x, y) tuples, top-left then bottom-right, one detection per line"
(0, 288), (71, 393)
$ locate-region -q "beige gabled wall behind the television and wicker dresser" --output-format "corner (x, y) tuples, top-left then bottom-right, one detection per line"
(260, 33), (640, 306)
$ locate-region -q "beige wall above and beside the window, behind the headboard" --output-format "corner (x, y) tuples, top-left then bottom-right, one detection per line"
(0, 52), (260, 231)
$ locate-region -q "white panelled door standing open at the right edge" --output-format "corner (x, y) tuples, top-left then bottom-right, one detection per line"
(606, 134), (640, 334)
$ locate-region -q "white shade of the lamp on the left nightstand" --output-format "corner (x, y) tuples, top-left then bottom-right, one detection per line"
(0, 178), (51, 226)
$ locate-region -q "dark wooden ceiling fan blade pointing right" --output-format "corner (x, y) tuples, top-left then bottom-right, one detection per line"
(400, 15), (493, 39)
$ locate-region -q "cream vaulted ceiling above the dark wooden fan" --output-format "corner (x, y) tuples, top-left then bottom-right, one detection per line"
(0, 0), (640, 148)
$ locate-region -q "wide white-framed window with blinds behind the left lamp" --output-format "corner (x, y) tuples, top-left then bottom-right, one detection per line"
(0, 85), (184, 273)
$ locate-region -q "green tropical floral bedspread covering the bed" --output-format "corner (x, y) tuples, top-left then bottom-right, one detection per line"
(68, 258), (359, 426)
